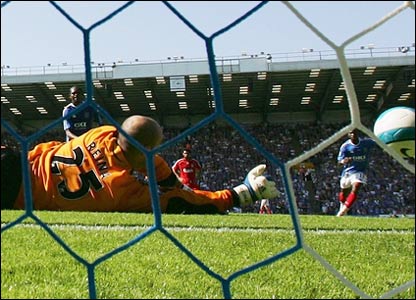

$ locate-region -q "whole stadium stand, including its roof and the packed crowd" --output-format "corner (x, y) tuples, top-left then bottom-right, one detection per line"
(1, 47), (415, 215)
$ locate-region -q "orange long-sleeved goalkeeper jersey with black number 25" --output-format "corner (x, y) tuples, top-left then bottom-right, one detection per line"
(14, 126), (232, 212)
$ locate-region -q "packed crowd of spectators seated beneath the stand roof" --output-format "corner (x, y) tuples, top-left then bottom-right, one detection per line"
(1, 123), (415, 216)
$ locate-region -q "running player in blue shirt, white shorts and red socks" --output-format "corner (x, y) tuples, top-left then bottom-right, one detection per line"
(337, 129), (377, 217)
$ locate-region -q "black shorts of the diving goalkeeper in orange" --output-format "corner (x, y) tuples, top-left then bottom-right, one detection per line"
(0, 146), (22, 209)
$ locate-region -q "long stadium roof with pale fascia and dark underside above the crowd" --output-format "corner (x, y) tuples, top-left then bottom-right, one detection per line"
(1, 54), (415, 123)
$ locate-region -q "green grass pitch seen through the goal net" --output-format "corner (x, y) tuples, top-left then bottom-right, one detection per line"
(1, 211), (415, 299)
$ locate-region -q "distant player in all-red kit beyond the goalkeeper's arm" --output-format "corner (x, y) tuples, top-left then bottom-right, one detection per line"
(172, 148), (202, 190)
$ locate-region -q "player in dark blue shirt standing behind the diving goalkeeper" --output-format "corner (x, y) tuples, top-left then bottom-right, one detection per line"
(62, 86), (102, 141)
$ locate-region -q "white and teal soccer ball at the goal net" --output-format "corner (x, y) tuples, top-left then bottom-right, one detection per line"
(373, 106), (415, 159)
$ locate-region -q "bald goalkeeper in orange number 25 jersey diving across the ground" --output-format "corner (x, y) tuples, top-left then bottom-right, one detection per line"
(1, 115), (278, 214)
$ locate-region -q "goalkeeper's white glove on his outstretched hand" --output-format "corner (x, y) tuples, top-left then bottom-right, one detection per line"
(233, 164), (279, 207)
